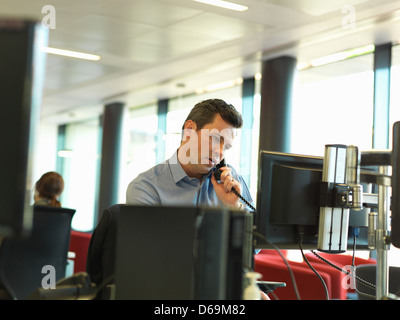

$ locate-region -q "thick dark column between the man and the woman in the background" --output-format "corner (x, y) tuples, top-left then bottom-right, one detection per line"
(94, 102), (124, 225)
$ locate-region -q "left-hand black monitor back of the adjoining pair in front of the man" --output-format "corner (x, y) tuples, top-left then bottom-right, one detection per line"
(115, 205), (197, 300)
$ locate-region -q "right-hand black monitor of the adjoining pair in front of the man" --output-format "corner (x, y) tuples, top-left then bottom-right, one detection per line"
(194, 209), (254, 300)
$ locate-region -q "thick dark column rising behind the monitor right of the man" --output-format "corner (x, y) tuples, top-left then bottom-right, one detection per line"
(259, 56), (296, 152)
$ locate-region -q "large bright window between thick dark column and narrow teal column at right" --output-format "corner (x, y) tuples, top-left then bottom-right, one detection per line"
(291, 54), (374, 156)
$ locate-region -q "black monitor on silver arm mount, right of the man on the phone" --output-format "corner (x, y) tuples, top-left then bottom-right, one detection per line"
(255, 151), (368, 250)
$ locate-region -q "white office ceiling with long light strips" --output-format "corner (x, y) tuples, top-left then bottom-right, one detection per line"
(0, 0), (400, 121)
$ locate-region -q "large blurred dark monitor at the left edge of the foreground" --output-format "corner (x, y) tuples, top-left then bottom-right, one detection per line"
(0, 17), (48, 236)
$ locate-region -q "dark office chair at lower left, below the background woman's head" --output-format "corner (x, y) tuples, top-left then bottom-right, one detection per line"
(0, 206), (75, 300)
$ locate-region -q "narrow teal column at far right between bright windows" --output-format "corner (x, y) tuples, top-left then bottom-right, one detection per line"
(372, 43), (392, 149)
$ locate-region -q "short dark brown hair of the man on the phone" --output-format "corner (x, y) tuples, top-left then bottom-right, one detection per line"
(182, 99), (243, 130)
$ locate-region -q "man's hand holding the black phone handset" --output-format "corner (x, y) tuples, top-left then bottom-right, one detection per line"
(211, 167), (242, 208)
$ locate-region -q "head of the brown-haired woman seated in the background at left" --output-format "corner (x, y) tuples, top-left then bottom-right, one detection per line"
(33, 171), (64, 207)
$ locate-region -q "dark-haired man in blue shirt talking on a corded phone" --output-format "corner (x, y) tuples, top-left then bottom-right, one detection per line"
(126, 99), (252, 209)
